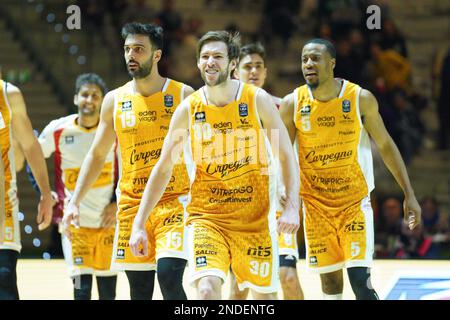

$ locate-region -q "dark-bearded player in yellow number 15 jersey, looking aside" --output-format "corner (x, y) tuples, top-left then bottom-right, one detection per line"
(64, 23), (193, 299)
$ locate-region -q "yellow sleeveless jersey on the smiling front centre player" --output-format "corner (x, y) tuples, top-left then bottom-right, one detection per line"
(187, 82), (276, 232)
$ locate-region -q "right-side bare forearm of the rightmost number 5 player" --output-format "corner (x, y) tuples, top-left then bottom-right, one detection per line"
(379, 138), (414, 196)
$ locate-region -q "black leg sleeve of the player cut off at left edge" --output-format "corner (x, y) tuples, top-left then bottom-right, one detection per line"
(0, 250), (19, 300)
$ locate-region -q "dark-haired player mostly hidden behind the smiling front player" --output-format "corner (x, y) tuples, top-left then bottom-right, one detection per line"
(230, 43), (303, 300)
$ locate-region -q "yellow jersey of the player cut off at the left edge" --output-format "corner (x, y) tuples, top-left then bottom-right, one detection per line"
(0, 80), (18, 225)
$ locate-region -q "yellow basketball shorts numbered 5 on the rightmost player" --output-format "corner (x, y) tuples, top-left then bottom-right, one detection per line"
(303, 197), (374, 273)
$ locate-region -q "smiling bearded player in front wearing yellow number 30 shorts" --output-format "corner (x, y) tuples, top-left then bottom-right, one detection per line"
(130, 31), (299, 299)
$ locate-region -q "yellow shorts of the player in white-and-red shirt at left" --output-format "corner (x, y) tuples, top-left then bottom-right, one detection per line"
(62, 226), (115, 277)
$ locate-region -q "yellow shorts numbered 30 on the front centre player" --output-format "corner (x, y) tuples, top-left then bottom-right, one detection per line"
(187, 220), (279, 293)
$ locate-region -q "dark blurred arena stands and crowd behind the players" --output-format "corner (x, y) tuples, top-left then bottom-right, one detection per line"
(0, 0), (450, 259)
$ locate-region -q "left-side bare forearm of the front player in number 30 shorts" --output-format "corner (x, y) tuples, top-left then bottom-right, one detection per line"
(134, 162), (173, 226)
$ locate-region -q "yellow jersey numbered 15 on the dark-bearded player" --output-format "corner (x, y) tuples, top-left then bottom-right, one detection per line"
(114, 79), (189, 218)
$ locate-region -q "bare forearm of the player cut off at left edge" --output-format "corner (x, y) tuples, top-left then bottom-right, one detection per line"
(23, 140), (51, 197)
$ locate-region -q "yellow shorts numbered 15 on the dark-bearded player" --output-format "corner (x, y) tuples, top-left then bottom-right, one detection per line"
(111, 196), (188, 271)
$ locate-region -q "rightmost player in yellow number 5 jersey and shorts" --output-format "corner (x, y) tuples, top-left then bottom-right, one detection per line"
(281, 39), (421, 300)
